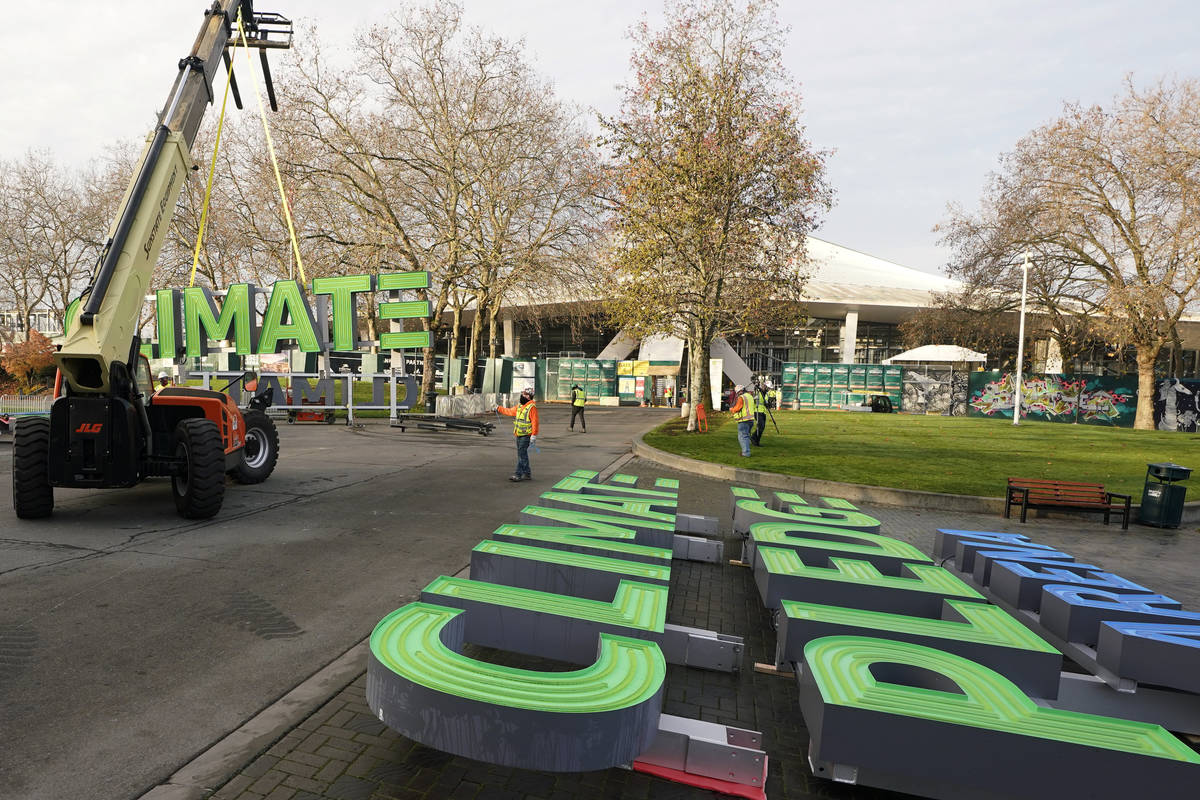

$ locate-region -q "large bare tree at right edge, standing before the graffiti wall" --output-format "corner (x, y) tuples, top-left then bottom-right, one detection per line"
(940, 80), (1200, 429)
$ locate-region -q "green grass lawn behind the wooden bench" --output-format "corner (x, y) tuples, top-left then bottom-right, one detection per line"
(646, 411), (1200, 503)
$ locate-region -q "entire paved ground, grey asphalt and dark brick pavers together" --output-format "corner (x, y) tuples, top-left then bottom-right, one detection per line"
(0, 405), (1200, 800)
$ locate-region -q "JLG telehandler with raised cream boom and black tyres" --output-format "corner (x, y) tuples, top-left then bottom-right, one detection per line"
(12, 0), (292, 519)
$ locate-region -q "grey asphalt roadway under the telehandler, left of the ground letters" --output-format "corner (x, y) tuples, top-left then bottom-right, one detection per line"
(0, 407), (671, 800)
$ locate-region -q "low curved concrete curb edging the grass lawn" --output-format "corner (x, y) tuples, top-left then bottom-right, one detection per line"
(632, 428), (1200, 522)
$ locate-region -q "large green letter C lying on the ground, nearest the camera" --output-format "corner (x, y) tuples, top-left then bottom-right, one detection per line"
(367, 602), (666, 771)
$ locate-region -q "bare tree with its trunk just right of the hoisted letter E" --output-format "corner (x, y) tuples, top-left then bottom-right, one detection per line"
(274, 4), (496, 393)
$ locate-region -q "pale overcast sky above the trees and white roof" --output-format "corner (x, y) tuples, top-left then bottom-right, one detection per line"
(0, 0), (1200, 272)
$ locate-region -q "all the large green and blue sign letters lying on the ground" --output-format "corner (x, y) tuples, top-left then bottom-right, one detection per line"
(367, 470), (1200, 800)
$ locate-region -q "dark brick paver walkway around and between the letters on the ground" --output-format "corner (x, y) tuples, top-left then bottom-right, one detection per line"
(212, 461), (1200, 800)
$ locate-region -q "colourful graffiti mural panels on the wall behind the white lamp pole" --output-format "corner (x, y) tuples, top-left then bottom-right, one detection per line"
(967, 371), (1132, 427)
